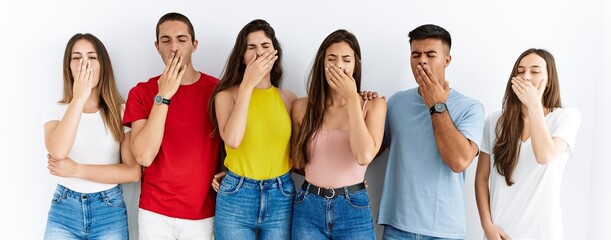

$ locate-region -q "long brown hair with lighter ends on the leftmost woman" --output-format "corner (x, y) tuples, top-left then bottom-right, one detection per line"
(59, 33), (125, 143)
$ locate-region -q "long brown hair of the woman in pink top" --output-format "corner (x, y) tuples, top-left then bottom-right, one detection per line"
(293, 29), (361, 169)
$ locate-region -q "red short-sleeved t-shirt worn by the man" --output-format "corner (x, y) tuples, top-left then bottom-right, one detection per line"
(123, 73), (219, 220)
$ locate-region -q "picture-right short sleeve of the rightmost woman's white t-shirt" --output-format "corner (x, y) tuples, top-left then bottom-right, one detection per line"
(550, 108), (581, 152)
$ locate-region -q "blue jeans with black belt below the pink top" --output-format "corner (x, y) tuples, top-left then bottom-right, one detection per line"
(293, 184), (375, 240)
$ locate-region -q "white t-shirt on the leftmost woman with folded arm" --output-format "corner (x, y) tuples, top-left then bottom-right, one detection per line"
(43, 103), (131, 193)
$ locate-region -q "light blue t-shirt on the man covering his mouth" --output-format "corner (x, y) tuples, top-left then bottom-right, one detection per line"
(378, 88), (485, 238)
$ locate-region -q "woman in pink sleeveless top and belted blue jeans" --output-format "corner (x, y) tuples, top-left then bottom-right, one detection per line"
(291, 29), (386, 239)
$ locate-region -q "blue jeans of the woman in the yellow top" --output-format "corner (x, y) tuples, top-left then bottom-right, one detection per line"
(214, 171), (295, 240)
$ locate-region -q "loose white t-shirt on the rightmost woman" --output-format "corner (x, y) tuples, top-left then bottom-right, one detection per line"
(481, 108), (581, 240)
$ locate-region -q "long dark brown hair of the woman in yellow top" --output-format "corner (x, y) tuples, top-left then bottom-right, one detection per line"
(208, 19), (283, 136)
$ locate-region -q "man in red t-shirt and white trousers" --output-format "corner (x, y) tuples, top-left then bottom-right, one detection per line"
(123, 13), (219, 239)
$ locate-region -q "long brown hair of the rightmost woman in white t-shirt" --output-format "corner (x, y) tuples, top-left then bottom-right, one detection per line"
(493, 48), (562, 186)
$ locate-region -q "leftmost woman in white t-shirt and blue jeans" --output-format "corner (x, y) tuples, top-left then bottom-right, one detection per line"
(43, 34), (141, 239)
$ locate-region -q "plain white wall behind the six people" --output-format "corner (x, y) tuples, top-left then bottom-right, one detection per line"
(0, 0), (611, 239)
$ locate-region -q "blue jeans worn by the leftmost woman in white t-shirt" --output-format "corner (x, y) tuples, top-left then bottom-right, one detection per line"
(44, 185), (129, 240)
